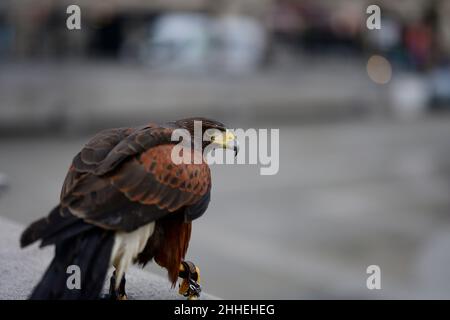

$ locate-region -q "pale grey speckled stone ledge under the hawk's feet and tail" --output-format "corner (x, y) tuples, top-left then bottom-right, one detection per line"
(0, 218), (214, 300)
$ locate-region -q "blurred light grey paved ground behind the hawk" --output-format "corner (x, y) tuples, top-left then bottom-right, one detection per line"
(0, 117), (450, 298)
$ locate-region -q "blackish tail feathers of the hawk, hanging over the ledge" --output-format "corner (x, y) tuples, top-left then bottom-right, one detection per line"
(30, 227), (114, 300)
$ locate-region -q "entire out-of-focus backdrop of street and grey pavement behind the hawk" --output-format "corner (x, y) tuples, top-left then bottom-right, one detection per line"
(0, 0), (450, 299)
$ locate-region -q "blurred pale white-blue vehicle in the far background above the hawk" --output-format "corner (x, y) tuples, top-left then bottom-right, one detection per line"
(140, 13), (267, 73)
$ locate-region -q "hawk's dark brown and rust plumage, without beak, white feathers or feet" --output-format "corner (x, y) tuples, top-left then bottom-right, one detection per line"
(21, 118), (236, 298)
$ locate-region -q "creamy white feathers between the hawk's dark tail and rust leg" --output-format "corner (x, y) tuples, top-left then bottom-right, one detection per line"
(110, 222), (155, 286)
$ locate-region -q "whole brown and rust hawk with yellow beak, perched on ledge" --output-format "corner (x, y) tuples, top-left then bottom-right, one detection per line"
(21, 118), (237, 299)
